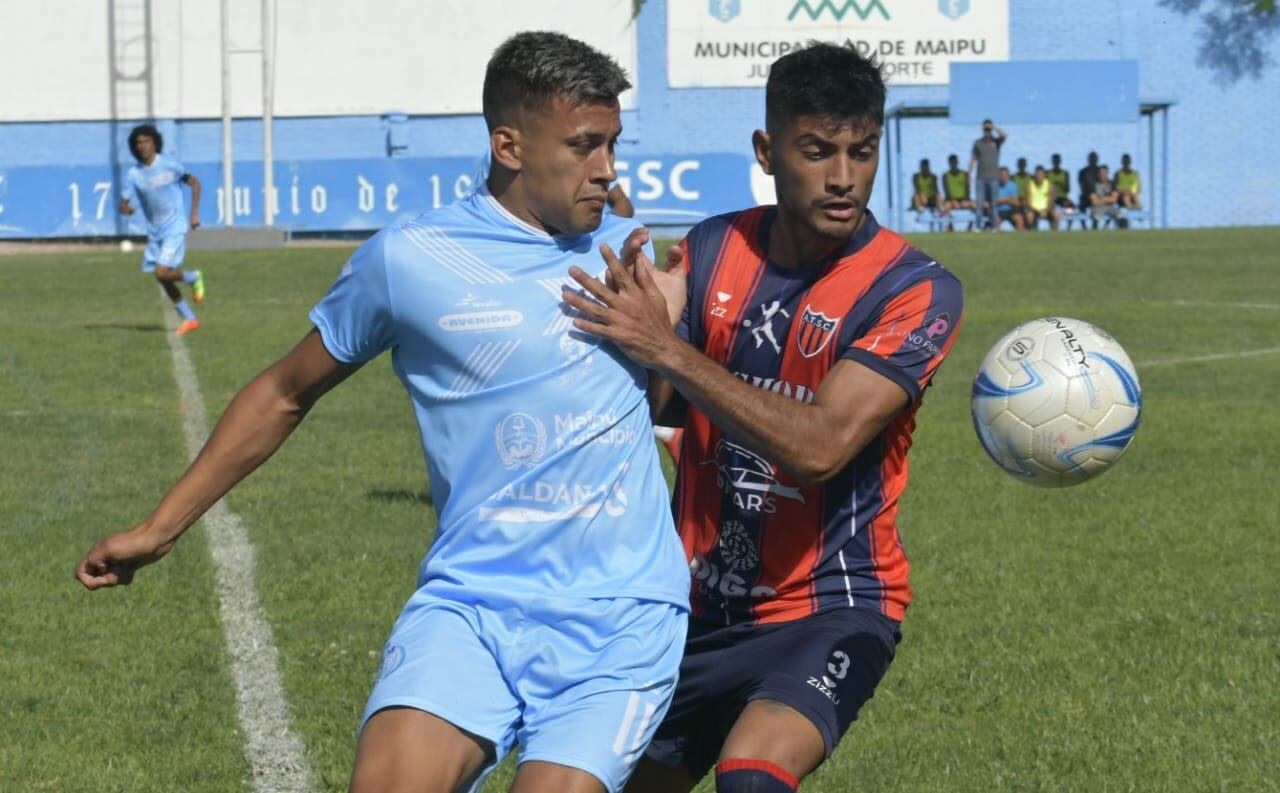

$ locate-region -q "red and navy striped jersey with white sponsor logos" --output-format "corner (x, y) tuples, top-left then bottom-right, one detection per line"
(673, 207), (963, 624)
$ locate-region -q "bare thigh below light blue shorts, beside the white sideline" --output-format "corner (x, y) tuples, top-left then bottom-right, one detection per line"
(351, 707), (491, 793)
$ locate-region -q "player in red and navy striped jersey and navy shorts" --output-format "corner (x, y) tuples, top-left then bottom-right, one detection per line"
(566, 43), (963, 793)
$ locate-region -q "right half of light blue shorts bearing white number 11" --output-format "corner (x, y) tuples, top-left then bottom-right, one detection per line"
(516, 599), (687, 793)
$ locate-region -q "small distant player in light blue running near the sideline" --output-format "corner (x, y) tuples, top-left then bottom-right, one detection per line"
(120, 124), (205, 334)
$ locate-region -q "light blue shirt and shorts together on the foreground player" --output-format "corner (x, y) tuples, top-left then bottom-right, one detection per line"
(311, 189), (689, 793)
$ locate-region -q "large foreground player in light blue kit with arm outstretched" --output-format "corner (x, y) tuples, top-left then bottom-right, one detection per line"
(77, 33), (689, 793)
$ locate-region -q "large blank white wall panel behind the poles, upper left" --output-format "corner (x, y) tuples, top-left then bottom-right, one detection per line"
(0, 0), (636, 122)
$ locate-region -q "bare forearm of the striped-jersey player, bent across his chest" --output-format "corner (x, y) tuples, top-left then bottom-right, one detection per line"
(659, 343), (847, 485)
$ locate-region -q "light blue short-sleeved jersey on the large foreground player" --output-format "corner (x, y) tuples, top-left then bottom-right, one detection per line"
(311, 185), (689, 609)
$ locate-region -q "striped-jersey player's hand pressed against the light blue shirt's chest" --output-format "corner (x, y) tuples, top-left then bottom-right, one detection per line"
(563, 244), (681, 368)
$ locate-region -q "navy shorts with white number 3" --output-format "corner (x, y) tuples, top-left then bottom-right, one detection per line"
(648, 609), (901, 779)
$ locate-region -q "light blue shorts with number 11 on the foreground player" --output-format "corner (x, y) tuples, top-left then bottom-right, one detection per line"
(361, 590), (687, 793)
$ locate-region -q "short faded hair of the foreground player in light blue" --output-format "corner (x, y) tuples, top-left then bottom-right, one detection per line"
(484, 31), (631, 132)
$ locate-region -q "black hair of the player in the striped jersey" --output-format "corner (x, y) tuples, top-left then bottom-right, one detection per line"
(764, 43), (884, 132)
